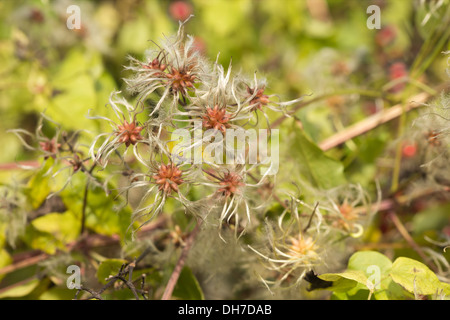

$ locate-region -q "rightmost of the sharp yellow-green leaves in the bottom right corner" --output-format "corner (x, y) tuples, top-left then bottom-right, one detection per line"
(390, 257), (448, 295)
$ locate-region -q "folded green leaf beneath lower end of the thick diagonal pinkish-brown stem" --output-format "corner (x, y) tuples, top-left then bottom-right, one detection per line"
(286, 124), (346, 189)
